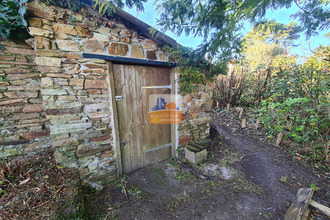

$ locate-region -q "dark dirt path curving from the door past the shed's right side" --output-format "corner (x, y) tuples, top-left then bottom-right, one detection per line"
(85, 118), (330, 220)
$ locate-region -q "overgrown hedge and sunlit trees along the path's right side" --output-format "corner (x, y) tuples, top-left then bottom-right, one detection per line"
(215, 21), (330, 166)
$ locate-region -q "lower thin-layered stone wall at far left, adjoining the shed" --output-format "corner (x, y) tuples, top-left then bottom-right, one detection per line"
(0, 39), (51, 159)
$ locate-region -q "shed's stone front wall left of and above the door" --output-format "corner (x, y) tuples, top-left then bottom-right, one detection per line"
(23, 1), (168, 186)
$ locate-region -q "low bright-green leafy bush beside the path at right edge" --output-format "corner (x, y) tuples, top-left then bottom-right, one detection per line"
(259, 97), (330, 143)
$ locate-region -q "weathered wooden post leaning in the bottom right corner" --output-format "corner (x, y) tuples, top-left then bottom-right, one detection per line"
(284, 188), (314, 220)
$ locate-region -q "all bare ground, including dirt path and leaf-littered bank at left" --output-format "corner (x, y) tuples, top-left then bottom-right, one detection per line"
(0, 112), (330, 220)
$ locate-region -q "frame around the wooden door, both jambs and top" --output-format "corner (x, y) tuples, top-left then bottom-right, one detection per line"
(107, 61), (180, 175)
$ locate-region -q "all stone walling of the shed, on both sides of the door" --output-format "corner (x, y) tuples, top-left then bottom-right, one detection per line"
(0, 1), (212, 187)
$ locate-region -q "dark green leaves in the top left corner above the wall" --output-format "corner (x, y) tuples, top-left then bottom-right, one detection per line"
(0, 0), (29, 40)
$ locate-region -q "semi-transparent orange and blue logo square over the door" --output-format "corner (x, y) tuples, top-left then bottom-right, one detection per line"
(149, 94), (182, 124)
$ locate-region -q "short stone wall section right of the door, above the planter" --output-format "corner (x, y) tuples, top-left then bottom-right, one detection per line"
(178, 82), (214, 145)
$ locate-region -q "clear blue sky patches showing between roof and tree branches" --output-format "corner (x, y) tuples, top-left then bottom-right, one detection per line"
(124, 0), (329, 58)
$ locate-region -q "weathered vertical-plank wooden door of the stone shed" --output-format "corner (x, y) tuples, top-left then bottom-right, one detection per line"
(112, 64), (171, 173)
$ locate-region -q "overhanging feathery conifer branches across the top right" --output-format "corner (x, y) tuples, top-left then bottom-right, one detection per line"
(157, 0), (330, 60)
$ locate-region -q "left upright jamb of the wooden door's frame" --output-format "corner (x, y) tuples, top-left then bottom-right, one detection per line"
(108, 62), (123, 175)
